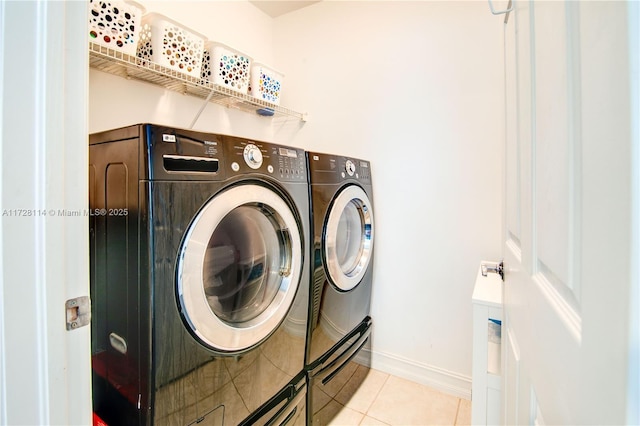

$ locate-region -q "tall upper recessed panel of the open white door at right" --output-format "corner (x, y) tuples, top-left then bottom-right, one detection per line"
(532, 2), (582, 309)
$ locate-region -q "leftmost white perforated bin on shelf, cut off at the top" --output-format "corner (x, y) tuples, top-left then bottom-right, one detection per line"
(89, 0), (145, 55)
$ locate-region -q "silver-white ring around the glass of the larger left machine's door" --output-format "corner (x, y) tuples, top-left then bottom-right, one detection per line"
(177, 184), (303, 352)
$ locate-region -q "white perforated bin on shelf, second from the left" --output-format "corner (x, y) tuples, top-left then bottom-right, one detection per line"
(138, 13), (206, 77)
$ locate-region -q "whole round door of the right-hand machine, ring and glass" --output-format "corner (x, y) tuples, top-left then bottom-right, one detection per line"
(323, 185), (373, 291)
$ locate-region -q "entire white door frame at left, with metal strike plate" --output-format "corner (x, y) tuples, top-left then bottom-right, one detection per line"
(0, 0), (91, 424)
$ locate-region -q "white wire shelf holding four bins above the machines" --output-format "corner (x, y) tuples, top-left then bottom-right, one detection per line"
(89, 42), (307, 121)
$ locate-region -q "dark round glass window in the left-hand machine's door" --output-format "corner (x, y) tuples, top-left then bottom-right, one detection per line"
(203, 204), (291, 323)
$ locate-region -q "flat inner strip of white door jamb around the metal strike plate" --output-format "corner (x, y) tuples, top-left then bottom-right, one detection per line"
(59, 1), (91, 425)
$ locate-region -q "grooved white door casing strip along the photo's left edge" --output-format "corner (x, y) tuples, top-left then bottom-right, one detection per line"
(2, 2), (51, 424)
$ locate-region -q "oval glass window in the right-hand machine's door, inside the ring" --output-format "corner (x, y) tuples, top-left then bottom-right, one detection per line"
(336, 200), (365, 275)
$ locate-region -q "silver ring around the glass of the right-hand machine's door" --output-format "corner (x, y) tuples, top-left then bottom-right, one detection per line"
(323, 185), (373, 291)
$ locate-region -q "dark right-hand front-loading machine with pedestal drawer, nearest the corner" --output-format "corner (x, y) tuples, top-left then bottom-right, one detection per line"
(306, 152), (374, 424)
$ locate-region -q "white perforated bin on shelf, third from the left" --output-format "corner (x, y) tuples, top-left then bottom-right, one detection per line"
(202, 41), (252, 93)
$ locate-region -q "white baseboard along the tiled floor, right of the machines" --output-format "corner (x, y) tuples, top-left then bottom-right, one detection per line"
(355, 348), (471, 400)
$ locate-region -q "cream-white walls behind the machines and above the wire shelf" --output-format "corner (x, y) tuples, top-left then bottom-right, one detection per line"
(89, 1), (503, 397)
